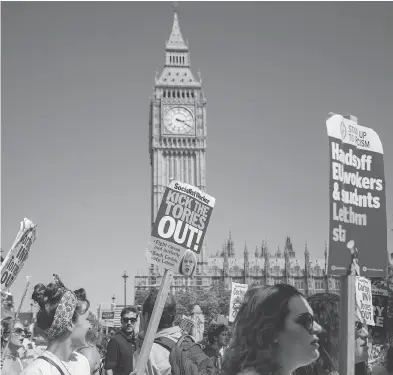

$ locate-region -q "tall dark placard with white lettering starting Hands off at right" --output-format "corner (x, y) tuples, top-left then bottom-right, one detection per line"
(326, 114), (388, 278)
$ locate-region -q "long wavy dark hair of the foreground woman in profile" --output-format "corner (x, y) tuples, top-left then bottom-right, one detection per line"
(223, 284), (302, 375)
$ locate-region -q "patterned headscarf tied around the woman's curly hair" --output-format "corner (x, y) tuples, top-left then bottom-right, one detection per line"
(45, 275), (78, 340)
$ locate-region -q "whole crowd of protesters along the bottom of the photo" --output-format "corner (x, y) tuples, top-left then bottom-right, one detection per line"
(1, 279), (393, 375)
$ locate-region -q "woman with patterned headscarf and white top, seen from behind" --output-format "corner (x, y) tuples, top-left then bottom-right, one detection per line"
(22, 277), (91, 375)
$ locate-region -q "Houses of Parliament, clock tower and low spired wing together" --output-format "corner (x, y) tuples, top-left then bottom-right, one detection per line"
(134, 9), (339, 295)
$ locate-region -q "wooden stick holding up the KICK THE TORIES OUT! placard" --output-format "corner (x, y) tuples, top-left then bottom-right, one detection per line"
(136, 270), (173, 375)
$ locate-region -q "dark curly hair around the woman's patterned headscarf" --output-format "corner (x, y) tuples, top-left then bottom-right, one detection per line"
(31, 283), (90, 330)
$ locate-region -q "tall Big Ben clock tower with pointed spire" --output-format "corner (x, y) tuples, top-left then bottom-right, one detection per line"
(149, 9), (206, 275)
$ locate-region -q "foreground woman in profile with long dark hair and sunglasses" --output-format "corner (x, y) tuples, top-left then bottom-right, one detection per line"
(223, 284), (321, 375)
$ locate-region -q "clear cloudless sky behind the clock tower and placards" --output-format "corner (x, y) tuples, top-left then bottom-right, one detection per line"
(1, 2), (393, 311)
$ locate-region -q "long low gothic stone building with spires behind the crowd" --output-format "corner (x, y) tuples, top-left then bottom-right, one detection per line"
(134, 234), (340, 296)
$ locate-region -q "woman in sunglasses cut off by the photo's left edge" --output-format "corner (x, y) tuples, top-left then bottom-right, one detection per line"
(1, 317), (25, 375)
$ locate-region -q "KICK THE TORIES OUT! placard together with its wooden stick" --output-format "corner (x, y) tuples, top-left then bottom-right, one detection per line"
(136, 180), (215, 375)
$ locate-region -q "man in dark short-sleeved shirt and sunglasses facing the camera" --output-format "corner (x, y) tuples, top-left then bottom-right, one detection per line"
(105, 306), (138, 375)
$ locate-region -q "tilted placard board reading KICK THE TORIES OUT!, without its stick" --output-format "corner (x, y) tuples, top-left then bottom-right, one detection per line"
(146, 180), (215, 276)
